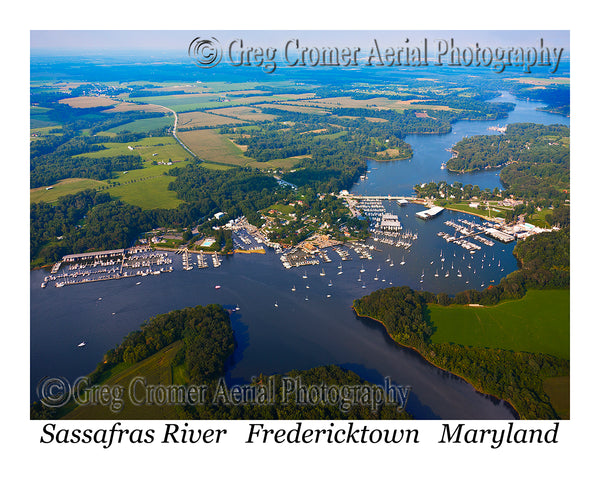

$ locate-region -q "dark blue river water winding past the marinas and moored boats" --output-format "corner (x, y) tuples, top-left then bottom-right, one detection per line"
(30, 94), (568, 419)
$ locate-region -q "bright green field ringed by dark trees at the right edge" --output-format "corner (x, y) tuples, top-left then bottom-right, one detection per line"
(429, 290), (570, 359)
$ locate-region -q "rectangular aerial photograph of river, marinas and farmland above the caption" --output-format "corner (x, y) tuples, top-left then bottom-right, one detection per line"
(28, 30), (571, 421)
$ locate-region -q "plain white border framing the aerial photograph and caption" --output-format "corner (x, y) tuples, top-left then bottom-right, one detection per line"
(0, 0), (599, 478)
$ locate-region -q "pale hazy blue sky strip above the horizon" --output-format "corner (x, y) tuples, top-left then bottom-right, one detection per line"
(30, 30), (570, 54)
